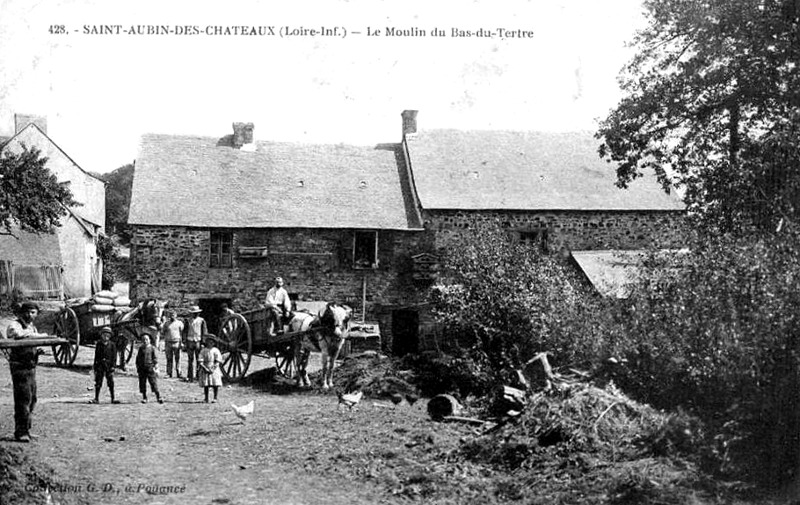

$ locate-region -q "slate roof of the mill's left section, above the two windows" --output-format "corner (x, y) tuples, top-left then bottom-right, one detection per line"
(128, 134), (422, 230)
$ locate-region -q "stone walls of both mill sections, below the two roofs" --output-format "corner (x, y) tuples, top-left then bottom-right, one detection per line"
(131, 211), (683, 351)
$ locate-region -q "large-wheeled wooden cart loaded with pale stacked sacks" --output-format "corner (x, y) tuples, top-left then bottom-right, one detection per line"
(52, 301), (146, 366)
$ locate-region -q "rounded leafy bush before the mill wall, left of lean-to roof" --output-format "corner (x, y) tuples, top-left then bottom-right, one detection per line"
(430, 222), (585, 381)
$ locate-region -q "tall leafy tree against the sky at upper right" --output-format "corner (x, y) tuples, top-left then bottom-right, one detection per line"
(598, 0), (800, 229)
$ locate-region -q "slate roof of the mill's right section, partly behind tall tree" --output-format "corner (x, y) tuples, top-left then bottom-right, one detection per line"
(407, 130), (684, 210)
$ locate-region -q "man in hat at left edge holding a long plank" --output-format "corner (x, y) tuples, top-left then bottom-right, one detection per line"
(6, 302), (48, 442)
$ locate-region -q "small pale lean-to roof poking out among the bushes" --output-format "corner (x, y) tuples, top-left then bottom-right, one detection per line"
(572, 250), (646, 298)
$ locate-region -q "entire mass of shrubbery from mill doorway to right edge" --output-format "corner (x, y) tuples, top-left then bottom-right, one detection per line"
(432, 219), (800, 484)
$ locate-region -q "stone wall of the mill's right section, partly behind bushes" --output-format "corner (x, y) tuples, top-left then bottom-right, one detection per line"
(424, 210), (685, 251)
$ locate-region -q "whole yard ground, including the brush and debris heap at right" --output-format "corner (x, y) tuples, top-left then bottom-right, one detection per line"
(0, 314), (797, 505)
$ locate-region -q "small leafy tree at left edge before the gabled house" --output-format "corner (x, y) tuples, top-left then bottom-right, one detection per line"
(0, 145), (79, 235)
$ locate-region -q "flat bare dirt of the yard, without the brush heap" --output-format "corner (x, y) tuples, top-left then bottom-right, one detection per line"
(0, 318), (456, 504)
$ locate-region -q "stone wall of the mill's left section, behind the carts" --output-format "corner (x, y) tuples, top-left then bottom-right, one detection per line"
(131, 226), (426, 319)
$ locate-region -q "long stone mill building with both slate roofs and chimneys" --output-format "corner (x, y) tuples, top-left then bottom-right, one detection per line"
(129, 111), (684, 352)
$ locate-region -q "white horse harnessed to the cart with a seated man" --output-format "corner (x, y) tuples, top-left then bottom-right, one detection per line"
(289, 302), (353, 389)
